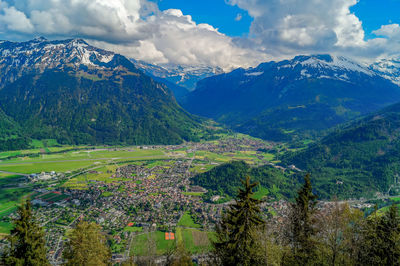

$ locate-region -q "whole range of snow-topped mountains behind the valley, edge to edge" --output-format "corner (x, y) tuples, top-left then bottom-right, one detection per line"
(0, 38), (400, 152)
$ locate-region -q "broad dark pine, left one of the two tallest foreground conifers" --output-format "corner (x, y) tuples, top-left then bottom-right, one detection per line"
(213, 177), (266, 266)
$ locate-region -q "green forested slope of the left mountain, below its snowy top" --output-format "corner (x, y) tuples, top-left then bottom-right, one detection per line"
(0, 70), (197, 144)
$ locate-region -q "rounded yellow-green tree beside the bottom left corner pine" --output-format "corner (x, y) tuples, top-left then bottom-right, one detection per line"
(63, 221), (111, 266)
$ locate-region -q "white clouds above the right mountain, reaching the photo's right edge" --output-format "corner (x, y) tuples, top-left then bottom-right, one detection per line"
(227, 0), (400, 62)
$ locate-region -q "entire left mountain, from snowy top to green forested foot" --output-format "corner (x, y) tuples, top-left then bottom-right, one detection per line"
(0, 38), (199, 148)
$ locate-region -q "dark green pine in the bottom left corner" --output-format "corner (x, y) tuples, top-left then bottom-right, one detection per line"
(2, 201), (50, 266)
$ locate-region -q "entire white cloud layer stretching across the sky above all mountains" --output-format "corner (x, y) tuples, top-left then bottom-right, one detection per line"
(0, 0), (400, 70)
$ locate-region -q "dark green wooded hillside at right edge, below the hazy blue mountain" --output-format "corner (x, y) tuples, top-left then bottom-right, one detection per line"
(281, 104), (400, 198)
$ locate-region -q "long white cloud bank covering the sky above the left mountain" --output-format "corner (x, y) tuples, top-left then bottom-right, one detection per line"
(0, 0), (266, 69)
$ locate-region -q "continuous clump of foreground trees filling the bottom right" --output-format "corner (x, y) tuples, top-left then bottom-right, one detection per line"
(211, 175), (400, 266)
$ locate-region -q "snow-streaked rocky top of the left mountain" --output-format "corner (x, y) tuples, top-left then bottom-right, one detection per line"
(0, 37), (115, 87)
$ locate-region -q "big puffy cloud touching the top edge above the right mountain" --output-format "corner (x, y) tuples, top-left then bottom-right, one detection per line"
(229, 0), (365, 53)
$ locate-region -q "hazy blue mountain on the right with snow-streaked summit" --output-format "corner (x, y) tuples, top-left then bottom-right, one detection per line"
(182, 55), (400, 141)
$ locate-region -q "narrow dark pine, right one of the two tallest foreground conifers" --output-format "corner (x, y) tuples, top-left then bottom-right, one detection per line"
(283, 174), (317, 265)
